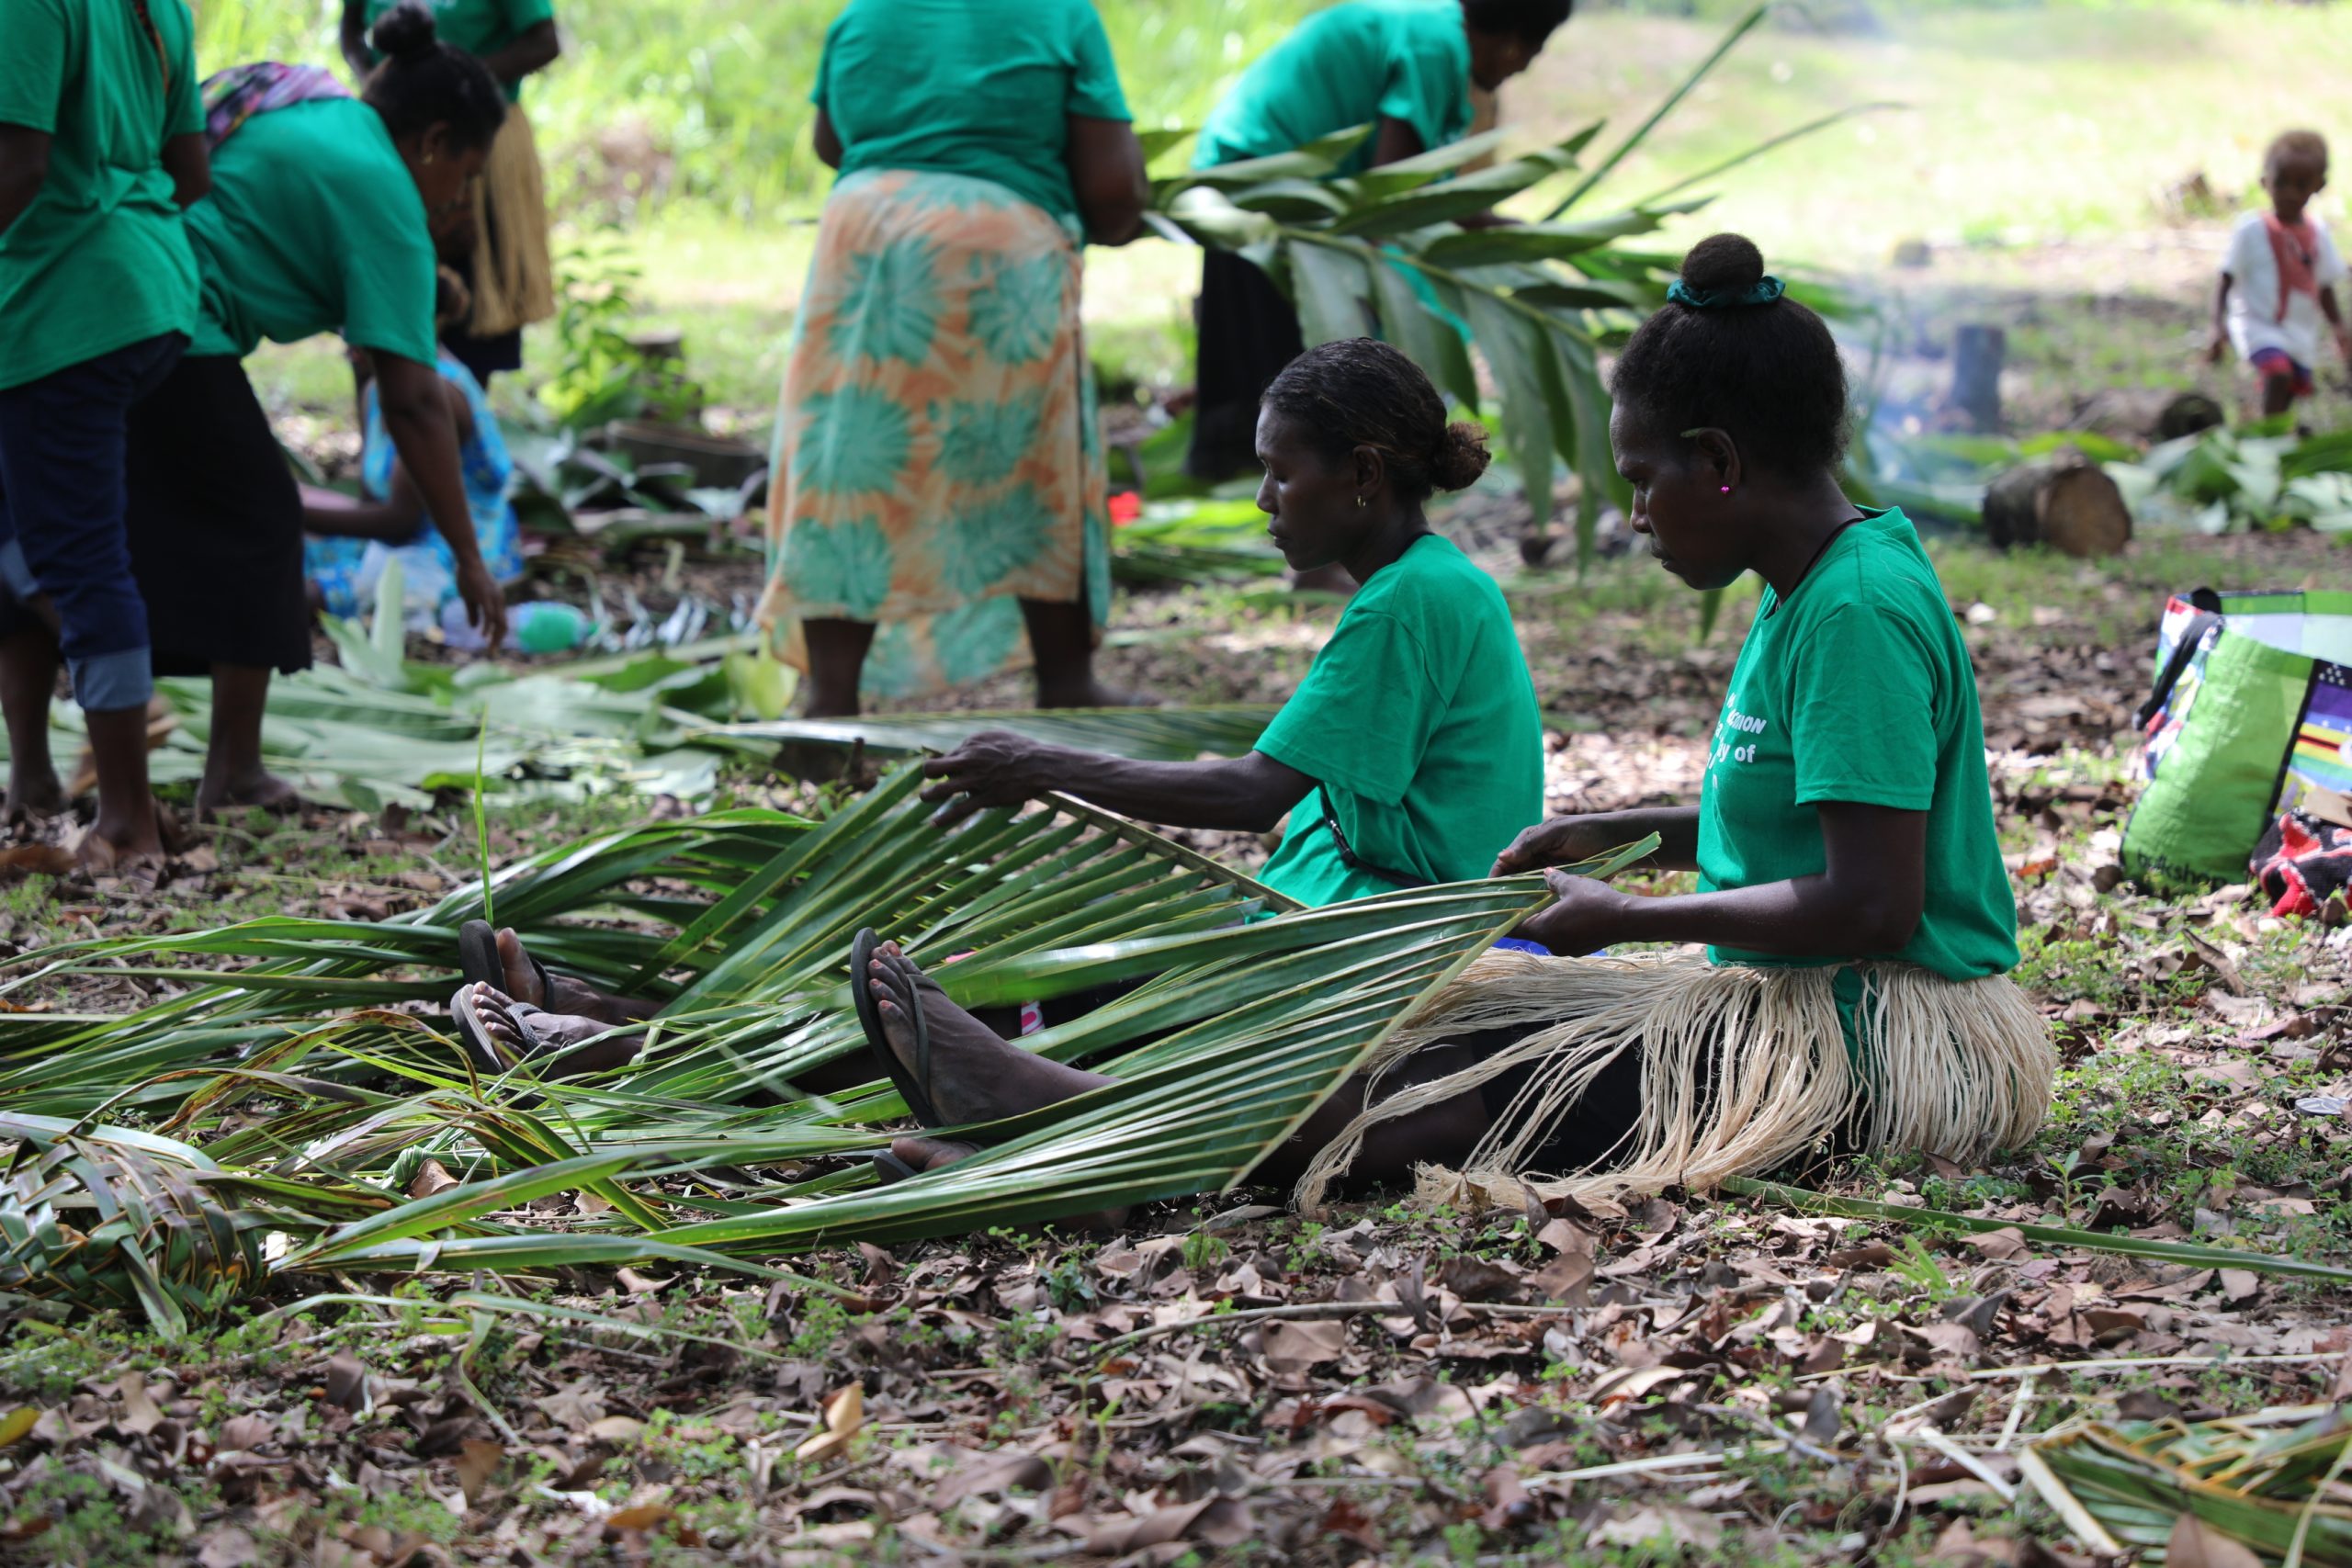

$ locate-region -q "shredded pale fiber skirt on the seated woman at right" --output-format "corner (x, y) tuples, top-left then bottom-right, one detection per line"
(1298, 950), (2058, 1211)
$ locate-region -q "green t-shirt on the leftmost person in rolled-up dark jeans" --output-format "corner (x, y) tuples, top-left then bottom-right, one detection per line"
(0, 0), (205, 388)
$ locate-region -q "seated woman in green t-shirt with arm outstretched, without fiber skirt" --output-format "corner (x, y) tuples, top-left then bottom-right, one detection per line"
(924, 339), (1543, 905)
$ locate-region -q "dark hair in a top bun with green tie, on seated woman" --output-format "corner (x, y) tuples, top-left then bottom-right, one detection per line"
(1609, 235), (1847, 478)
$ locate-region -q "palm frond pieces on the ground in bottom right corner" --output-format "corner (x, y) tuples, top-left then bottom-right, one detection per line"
(2032, 1405), (2352, 1568)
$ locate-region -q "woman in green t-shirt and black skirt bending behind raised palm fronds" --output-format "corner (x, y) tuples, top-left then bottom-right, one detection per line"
(1185, 0), (1574, 479)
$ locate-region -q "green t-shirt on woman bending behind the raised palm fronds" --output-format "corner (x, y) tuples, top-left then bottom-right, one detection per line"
(1193, 0), (1470, 174)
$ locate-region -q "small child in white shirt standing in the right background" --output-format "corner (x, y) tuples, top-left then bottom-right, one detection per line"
(2211, 131), (2352, 416)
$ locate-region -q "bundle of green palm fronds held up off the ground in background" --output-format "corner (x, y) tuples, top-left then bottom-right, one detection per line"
(1146, 3), (1886, 559)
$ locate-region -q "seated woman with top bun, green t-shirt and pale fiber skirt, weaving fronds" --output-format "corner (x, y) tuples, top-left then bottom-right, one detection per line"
(448, 235), (2055, 1203)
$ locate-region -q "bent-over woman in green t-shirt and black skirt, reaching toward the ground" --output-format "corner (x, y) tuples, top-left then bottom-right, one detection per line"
(130, 5), (505, 811)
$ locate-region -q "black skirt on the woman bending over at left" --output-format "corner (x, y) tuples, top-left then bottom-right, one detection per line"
(125, 355), (311, 674)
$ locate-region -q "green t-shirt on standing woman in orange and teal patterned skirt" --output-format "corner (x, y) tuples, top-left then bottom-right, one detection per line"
(809, 0), (1129, 219)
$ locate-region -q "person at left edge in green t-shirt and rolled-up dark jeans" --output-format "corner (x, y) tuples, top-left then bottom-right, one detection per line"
(0, 0), (207, 874)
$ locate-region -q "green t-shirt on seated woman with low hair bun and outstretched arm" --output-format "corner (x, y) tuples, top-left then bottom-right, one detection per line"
(1259, 534), (1543, 905)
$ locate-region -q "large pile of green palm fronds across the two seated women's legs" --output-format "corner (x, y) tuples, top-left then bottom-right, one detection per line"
(0, 766), (1636, 1325)
